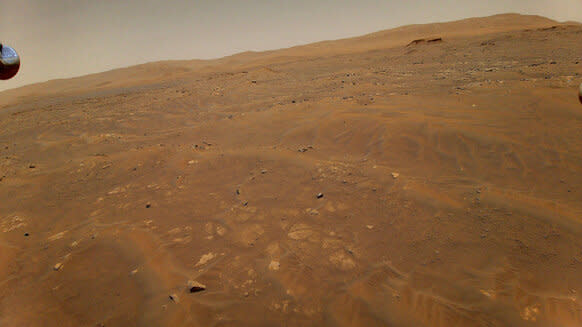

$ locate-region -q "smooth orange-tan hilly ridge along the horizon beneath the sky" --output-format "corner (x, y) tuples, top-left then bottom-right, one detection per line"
(0, 14), (557, 105)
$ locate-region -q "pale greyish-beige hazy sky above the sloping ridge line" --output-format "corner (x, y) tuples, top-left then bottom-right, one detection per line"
(0, 0), (582, 90)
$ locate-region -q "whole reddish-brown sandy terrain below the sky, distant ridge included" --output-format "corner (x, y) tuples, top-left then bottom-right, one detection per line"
(0, 15), (582, 327)
